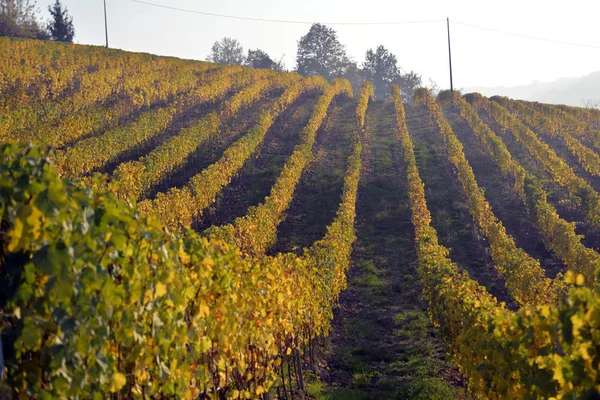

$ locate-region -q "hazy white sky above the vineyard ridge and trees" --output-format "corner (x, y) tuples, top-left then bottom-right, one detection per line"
(37, 0), (600, 88)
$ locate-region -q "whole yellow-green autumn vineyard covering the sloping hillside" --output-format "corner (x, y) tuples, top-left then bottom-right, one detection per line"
(0, 38), (600, 399)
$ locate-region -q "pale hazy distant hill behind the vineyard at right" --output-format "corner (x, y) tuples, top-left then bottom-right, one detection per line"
(464, 71), (600, 107)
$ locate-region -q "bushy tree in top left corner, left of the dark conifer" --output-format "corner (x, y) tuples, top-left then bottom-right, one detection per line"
(0, 0), (47, 39)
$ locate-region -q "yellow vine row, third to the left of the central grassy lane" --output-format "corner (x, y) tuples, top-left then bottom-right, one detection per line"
(140, 77), (328, 228)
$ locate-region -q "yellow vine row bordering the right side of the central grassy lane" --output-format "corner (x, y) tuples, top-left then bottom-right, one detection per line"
(393, 86), (600, 399)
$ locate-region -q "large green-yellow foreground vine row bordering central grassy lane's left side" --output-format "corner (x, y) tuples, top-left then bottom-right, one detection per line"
(0, 79), (368, 398)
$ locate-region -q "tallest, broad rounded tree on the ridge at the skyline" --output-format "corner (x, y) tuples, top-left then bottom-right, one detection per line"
(296, 24), (351, 79)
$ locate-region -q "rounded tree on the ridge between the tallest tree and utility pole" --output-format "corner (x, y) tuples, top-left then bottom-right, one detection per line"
(363, 46), (400, 100)
